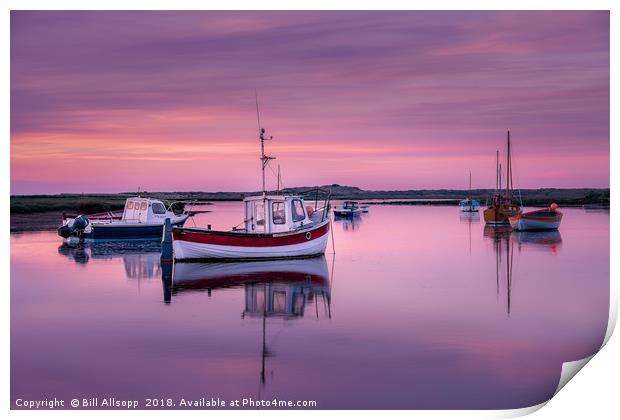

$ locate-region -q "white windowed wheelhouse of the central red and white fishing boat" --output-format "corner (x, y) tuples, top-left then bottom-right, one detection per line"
(243, 195), (312, 233)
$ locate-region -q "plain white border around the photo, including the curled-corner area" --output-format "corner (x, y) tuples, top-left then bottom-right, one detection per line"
(0, 0), (620, 419)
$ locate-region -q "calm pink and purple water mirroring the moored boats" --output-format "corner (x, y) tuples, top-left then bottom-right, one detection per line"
(11, 203), (609, 409)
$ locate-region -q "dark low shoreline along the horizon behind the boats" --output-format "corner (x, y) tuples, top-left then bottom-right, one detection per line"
(11, 184), (610, 232)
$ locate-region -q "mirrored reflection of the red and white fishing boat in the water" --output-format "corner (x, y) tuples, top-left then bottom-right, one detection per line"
(162, 255), (331, 386)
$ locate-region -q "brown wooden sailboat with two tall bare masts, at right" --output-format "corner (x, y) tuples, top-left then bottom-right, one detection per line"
(484, 131), (521, 225)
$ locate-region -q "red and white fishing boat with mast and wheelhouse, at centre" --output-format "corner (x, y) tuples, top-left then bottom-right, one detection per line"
(172, 116), (330, 260)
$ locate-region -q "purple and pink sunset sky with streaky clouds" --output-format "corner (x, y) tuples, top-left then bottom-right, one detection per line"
(11, 11), (609, 194)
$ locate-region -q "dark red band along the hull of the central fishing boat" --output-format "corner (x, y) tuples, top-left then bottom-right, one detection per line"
(172, 223), (329, 247)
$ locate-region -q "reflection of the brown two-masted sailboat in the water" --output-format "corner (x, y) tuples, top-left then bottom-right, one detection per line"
(484, 225), (514, 316)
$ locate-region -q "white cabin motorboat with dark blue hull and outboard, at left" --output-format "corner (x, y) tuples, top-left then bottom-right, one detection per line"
(58, 197), (190, 239)
